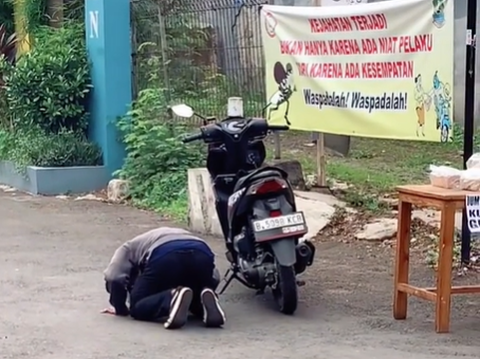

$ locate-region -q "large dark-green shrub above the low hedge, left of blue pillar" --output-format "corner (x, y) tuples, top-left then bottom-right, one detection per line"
(0, 25), (91, 133)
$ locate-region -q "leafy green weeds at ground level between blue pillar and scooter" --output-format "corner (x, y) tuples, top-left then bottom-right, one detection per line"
(118, 88), (203, 218)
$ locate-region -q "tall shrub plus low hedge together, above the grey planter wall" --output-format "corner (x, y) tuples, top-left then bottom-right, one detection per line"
(0, 23), (102, 169)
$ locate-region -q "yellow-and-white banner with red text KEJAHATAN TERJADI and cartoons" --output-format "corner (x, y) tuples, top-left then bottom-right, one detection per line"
(261, 0), (454, 142)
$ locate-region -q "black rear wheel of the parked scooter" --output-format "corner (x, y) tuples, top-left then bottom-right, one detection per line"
(272, 265), (298, 315)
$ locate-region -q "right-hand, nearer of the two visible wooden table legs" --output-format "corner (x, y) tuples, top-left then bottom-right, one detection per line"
(435, 203), (455, 333)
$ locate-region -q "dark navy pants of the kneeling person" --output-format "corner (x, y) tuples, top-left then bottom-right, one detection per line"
(130, 242), (218, 321)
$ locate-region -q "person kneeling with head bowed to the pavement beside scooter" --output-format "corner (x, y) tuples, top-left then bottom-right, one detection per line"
(103, 227), (225, 329)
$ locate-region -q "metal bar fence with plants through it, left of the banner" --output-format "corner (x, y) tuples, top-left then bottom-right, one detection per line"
(132, 0), (266, 121)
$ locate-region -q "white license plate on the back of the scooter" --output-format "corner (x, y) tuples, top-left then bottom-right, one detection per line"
(252, 212), (308, 241)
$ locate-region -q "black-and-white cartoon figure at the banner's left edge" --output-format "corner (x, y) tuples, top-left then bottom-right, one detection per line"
(265, 61), (297, 126)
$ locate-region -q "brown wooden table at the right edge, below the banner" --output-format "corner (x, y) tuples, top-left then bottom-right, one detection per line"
(393, 185), (480, 333)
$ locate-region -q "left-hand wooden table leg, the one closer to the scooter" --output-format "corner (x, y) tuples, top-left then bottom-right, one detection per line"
(393, 199), (412, 319)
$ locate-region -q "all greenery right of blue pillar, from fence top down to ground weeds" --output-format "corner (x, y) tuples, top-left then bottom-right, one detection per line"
(125, 0), (264, 220)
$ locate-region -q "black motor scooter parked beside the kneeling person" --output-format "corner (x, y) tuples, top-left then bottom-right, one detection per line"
(171, 105), (315, 314)
